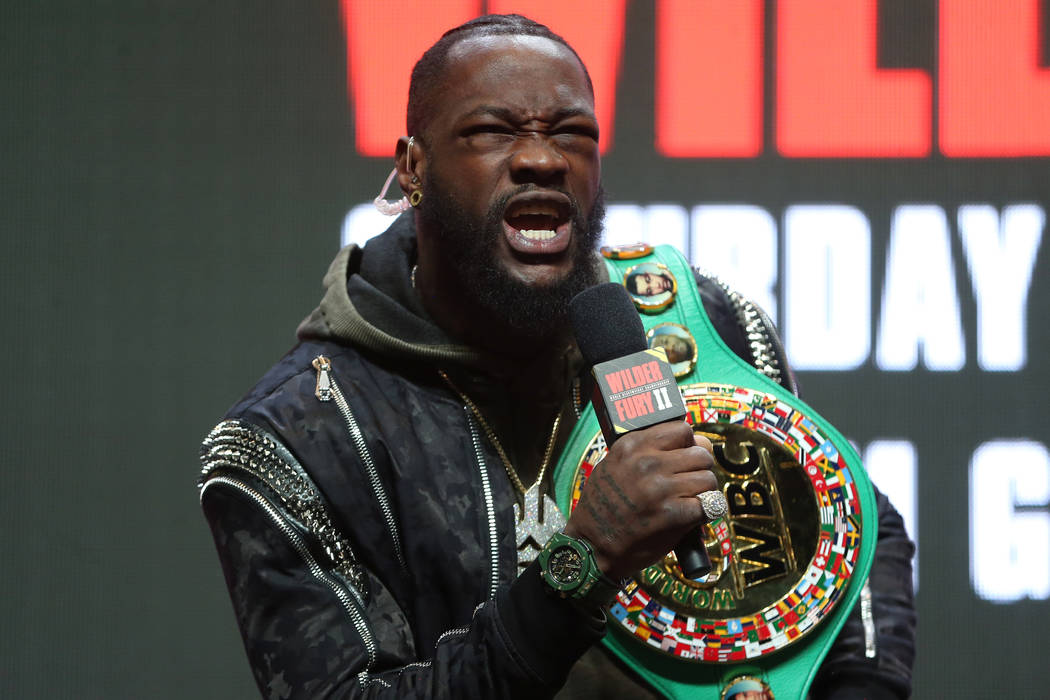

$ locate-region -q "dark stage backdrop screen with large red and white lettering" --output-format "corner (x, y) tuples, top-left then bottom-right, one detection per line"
(0, 0), (1050, 698)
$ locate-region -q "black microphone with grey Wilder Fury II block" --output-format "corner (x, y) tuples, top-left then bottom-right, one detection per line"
(569, 282), (711, 579)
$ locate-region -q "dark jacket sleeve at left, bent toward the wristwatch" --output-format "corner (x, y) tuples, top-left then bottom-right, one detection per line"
(201, 421), (605, 699)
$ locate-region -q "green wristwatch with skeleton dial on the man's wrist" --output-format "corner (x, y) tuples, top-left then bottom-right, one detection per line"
(540, 532), (620, 608)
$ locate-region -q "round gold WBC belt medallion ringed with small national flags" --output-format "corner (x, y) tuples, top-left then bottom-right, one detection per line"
(571, 384), (861, 663)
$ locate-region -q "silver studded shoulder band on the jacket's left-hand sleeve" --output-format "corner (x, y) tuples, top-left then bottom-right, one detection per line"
(197, 421), (368, 595)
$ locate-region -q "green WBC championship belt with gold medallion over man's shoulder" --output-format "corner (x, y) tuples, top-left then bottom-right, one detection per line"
(553, 245), (877, 700)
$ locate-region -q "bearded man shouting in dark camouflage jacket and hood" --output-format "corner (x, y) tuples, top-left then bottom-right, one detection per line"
(201, 16), (912, 698)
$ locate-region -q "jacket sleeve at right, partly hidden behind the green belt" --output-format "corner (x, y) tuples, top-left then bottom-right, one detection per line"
(696, 272), (916, 700)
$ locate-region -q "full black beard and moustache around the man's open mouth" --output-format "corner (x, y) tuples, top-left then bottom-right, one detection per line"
(418, 173), (605, 338)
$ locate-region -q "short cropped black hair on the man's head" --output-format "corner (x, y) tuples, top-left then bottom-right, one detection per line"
(405, 15), (594, 136)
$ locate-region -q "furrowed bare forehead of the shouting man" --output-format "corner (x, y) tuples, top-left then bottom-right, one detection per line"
(434, 35), (594, 125)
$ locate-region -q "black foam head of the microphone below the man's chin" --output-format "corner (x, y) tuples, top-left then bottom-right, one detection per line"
(569, 282), (649, 365)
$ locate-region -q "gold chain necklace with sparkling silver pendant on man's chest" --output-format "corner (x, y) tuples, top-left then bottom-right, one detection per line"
(438, 369), (575, 574)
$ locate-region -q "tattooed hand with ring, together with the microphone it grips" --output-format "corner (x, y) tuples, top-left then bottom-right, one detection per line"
(566, 283), (726, 578)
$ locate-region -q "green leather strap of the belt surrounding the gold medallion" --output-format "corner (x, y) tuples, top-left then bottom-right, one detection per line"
(553, 246), (878, 700)
